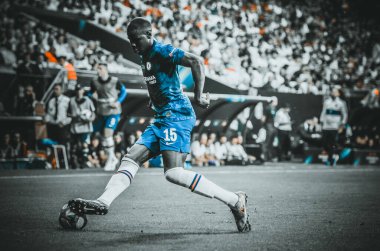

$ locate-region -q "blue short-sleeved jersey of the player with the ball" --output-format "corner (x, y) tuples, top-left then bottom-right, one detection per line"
(141, 40), (195, 121)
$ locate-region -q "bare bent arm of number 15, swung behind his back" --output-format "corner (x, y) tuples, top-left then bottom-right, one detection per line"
(181, 52), (210, 108)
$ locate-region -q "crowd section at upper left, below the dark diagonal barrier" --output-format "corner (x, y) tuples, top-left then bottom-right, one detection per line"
(0, 1), (137, 75)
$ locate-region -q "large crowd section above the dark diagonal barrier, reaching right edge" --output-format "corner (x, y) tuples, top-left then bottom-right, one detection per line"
(24, 0), (380, 94)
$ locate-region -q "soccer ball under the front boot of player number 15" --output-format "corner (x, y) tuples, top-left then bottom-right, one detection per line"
(58, 204), (87, 230)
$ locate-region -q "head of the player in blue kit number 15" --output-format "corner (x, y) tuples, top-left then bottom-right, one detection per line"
(127, 17), (153, 55)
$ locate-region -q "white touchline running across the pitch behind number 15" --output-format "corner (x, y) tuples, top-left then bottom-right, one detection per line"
(0, 168), (380, 180)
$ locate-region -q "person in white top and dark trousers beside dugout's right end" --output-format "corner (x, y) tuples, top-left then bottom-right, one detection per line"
(274, 104), (292, 161)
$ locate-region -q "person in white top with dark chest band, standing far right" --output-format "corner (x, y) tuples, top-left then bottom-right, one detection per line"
(320, 87), (348, 165)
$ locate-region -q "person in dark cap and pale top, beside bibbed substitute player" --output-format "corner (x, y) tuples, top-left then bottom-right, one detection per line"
(69, 84), (95, 168)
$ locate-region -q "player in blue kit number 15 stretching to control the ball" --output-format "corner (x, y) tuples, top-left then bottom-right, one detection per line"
(69, 18), (251, 232)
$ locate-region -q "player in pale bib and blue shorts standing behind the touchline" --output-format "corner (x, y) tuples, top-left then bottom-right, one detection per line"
(90, 62), (127, 171)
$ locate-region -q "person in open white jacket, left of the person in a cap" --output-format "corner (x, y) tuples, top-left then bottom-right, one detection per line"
(45, 83), (71, 145)
